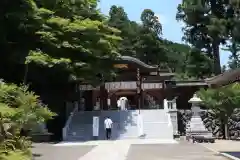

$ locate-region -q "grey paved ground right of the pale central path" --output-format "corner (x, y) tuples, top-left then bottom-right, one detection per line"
(127, 143), (228, 160)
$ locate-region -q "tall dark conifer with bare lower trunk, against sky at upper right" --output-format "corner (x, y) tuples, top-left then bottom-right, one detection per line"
(176, 0), (229, 74)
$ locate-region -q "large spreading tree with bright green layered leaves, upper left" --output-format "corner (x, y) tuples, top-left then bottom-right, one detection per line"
(0, 0), (121, 86)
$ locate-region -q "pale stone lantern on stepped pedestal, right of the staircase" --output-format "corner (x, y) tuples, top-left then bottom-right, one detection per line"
(186, 94), (214, 142)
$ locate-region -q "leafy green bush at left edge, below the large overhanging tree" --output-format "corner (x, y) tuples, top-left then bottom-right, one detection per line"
(0, 83), (55, 126)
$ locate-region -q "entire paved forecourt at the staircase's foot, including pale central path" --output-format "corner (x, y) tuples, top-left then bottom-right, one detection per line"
(33, 140), (227, 160)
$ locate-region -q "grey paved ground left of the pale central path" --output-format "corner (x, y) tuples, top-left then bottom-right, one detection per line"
(32, 143), (94, 160)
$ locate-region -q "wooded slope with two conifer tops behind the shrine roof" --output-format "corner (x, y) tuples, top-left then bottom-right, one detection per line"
(108, 5), (213, 79)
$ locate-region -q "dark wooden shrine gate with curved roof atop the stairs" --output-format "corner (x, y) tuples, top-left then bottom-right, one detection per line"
(79, 56), (207, 111)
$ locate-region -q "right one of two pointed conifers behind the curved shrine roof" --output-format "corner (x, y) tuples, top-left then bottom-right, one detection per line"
(135, 9), (166, 65)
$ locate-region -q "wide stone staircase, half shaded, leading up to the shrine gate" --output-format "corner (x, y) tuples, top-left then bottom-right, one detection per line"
(65, 109), (173, 141)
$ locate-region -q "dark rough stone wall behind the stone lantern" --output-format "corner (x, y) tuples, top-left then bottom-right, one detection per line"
(178, 109), (240, 139)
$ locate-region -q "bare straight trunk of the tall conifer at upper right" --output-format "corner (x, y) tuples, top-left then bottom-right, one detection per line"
(212, 42), (221, 75)
